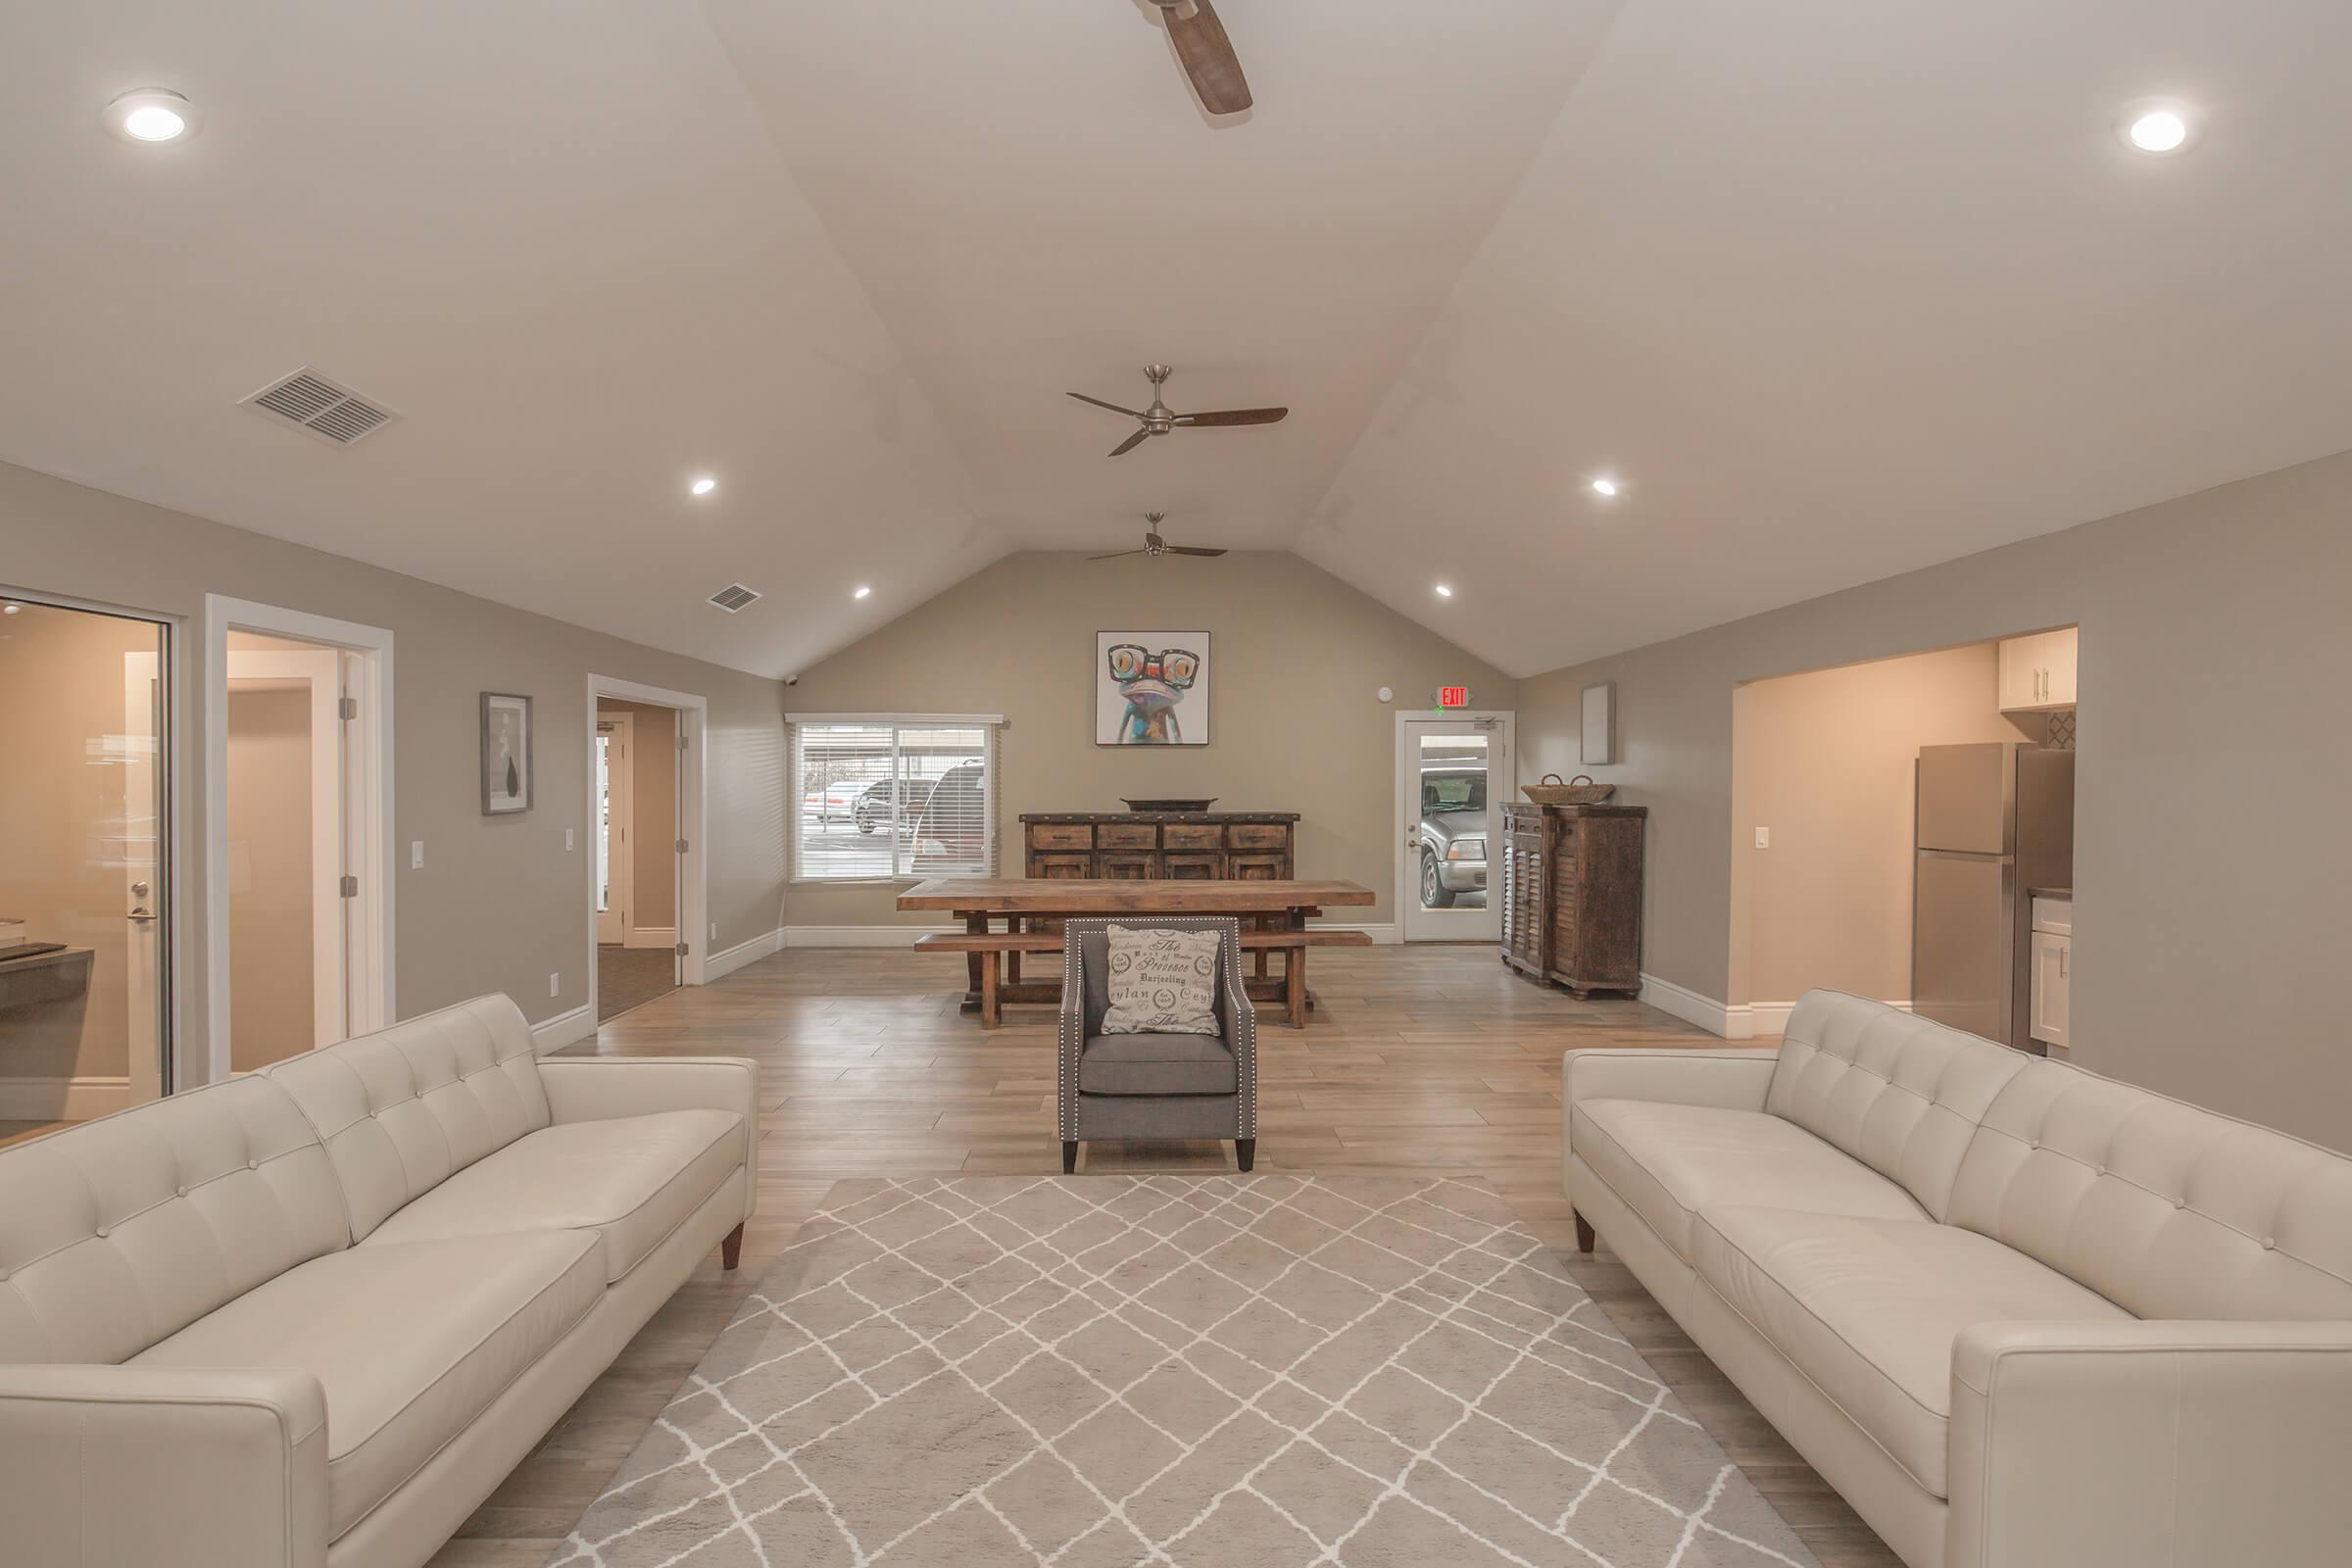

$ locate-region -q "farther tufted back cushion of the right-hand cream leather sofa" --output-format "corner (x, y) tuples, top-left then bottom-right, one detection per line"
(1764, 990), (2028, 1220)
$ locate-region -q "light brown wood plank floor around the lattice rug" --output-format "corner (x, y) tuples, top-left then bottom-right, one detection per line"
(433, 948), (1900, 1568)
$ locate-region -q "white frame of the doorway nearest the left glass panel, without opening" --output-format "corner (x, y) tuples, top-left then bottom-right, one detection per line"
(205, 592), (398, 1084)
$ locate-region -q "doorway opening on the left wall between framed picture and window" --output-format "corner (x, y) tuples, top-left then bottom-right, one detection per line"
(588, 694), (684, 1022)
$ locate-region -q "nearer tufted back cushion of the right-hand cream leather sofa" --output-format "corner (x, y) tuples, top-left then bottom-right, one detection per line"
(1950, 1060), (2352, 1321)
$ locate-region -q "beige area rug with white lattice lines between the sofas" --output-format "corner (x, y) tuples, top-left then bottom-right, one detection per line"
(553, 1175), (1816, 1568)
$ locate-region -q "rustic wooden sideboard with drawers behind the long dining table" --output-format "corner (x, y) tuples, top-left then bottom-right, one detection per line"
(1021, 811), (1298, 882)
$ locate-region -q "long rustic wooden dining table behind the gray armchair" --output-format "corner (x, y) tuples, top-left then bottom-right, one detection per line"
(899, 877), (1376, 1027)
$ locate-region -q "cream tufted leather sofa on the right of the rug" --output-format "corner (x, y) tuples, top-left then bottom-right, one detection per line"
(1562, 992), (2352, 1568)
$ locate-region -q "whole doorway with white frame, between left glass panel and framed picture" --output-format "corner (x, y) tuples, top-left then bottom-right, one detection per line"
(205, 595), (393, 1081)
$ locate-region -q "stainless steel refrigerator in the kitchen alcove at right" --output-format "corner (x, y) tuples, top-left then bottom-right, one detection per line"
(1912, 741), (2075, 1055)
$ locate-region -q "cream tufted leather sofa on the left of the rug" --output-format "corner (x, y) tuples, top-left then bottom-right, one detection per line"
(0, 997), (760, 1568)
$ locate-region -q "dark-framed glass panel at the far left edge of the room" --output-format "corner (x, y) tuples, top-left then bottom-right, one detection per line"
(0, 600), (172, 1143)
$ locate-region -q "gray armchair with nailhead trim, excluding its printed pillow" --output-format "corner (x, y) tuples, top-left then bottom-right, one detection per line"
(1054, 914), (1258, 1171)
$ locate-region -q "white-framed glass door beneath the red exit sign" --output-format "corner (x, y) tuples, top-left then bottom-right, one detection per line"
(1397, 719), (1510, 943)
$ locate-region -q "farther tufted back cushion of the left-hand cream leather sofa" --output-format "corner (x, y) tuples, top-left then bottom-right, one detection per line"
(264, 997), (548, 1242)
